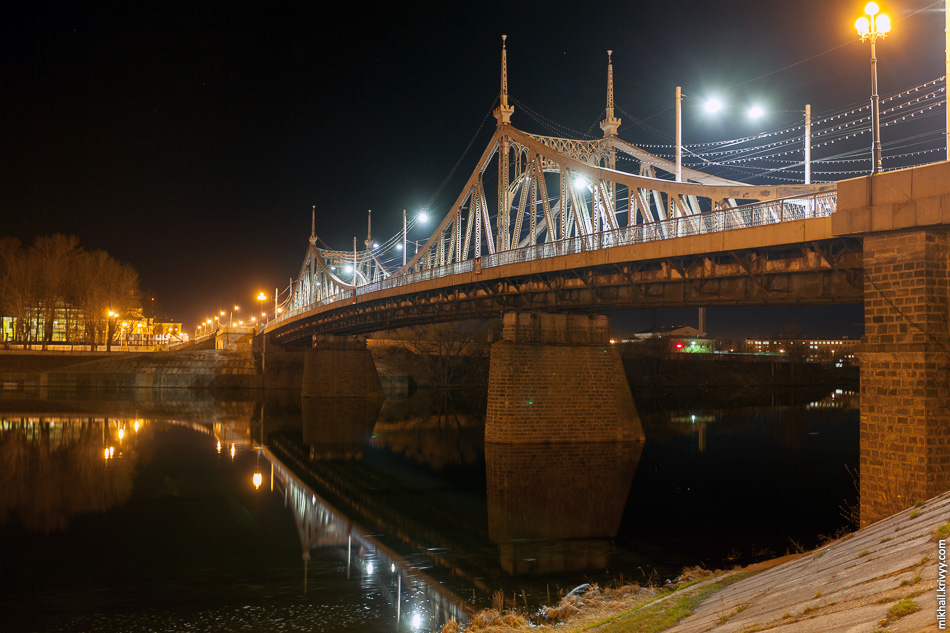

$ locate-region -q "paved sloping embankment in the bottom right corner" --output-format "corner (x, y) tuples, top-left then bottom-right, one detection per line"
(660, 493), (950, 633)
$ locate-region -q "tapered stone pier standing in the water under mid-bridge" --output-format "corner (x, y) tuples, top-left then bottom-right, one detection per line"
(485, 312), (645, 444)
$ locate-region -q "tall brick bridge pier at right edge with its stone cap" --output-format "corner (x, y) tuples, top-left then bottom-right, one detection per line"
(832, 163), (950, 525)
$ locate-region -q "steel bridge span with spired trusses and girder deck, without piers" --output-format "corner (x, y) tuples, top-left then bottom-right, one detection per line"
(265, 36), (848, 343)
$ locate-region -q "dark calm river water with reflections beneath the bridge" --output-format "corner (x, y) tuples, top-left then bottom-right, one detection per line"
(0, 382), (858, 632)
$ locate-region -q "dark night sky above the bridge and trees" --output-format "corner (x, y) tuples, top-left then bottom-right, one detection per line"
(0, 0), (945, 335)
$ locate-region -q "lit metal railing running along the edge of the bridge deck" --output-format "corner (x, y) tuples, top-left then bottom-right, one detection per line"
(276, 191), (838, 323)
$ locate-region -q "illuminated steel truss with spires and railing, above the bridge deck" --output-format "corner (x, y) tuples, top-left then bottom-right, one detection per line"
(277, 40), (836, 325)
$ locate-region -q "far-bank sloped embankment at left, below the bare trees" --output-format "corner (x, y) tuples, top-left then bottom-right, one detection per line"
(0, 350), (260, 389)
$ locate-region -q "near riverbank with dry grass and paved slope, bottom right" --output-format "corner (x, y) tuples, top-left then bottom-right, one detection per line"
(443, 492), (950, 633)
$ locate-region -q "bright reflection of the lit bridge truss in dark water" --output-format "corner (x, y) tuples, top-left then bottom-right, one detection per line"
(263, 448), (470, 631)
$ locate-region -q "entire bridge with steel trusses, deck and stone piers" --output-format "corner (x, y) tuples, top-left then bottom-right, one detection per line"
(256, 38), (950, 522)
